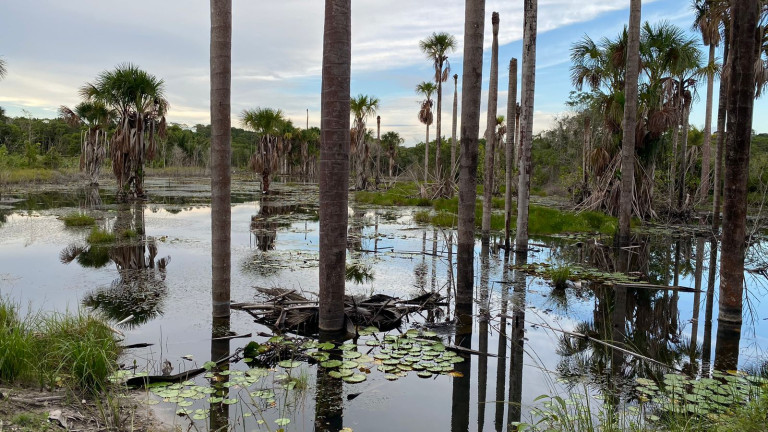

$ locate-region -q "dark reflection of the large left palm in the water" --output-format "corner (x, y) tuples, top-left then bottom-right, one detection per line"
(68, 203), (170, 328)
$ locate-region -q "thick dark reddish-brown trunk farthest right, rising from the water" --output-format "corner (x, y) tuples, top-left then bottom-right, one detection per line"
(715, 0), (759, 370)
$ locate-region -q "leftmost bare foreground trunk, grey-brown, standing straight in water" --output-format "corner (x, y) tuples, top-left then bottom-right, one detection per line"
(210, 0), (232, 321)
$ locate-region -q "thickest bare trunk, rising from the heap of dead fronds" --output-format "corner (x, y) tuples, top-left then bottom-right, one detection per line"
(319, 0), (352, 332)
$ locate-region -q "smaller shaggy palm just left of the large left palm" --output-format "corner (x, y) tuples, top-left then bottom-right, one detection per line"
(59, 101), (113, 186)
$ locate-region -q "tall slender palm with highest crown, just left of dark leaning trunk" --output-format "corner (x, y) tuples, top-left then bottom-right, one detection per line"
(419, 32), (457, 183)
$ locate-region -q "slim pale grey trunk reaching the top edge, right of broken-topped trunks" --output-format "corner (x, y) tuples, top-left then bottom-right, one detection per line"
(515, 0), (538, 251)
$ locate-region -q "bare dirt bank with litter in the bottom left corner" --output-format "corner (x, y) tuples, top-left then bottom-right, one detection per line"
(0, 387), (175, 432)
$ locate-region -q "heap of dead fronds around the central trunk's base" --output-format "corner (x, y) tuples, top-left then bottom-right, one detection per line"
(231, 287), (447, 335)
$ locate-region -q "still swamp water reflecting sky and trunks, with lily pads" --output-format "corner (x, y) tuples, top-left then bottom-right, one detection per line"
(0, 179), (768, 431)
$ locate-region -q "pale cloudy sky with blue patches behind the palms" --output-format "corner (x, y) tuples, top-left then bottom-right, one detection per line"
(0, 0), (768, 145)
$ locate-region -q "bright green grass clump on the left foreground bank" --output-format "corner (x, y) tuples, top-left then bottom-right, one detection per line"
(0, 300), (120, 391)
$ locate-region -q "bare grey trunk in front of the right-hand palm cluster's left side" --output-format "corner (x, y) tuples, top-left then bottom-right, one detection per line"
(618, 0), (642, 244)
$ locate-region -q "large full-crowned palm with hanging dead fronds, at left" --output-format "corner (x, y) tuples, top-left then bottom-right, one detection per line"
(80, 63), (169, 198)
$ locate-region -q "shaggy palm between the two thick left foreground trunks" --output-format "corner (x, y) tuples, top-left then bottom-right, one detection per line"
(240, 108), (286, 194)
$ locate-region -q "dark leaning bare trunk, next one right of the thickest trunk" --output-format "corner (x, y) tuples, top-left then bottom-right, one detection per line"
(456, 0), (485, 320)
